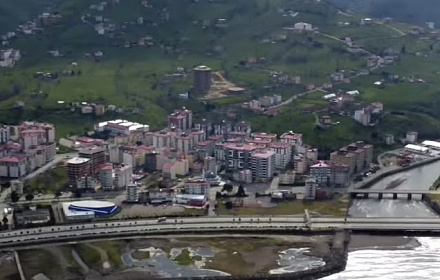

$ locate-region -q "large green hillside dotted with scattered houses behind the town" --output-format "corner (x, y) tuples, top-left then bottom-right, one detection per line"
(0, 0), (440, 152)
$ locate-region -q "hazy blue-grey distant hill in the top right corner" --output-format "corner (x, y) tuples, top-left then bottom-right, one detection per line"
(330, 0), (440, 26)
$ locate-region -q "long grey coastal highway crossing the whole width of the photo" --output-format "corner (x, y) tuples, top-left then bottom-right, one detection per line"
(0, 216), (440, 248)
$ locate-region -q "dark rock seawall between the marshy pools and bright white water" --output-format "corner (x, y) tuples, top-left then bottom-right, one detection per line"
(185, 231), (350, 280)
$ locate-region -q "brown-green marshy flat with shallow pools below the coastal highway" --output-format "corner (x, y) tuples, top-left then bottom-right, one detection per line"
(15, 235), (333, 280)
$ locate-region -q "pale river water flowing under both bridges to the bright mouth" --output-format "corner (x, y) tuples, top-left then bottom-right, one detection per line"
(330, 162), (440, 280)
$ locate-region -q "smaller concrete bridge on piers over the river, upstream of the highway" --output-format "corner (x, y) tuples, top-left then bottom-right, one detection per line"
(349, 189), (434, 200)
